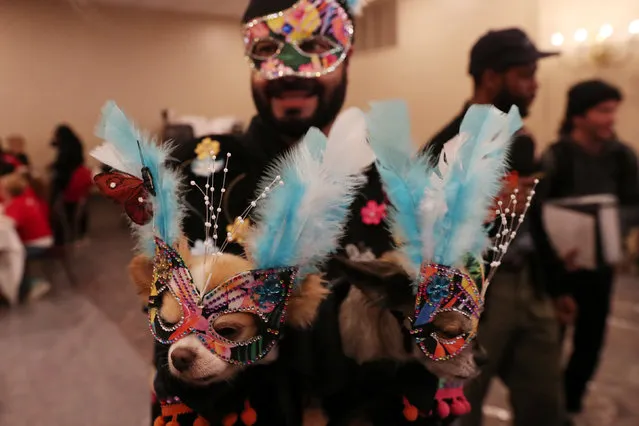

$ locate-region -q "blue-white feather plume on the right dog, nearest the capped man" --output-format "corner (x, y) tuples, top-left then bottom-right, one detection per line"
(428, 105), (522, 266)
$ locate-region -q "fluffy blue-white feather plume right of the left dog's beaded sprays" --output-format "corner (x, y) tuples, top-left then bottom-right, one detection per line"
(248, 110), (372, 275)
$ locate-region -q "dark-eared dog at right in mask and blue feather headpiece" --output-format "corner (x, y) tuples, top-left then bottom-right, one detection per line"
(320, 102), (530, 425)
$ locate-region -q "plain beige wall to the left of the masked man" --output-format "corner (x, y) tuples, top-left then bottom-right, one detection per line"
(0, 0), (252, 171)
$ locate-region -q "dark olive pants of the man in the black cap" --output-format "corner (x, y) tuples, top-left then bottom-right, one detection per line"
(460, 269), (563, 426)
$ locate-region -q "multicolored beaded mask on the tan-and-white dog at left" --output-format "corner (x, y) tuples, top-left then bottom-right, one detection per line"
(149, 238), (297, 365)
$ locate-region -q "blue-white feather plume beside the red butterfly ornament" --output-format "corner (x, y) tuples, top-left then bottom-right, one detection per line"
(91, 101), (184, 257)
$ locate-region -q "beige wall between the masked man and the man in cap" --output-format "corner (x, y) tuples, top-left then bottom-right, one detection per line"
(348, 0), (538, 143)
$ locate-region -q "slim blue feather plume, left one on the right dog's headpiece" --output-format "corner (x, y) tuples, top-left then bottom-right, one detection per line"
(367, 101), (432, 271)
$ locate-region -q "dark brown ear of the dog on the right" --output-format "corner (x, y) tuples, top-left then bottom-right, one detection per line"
(332, 256), (415, 311)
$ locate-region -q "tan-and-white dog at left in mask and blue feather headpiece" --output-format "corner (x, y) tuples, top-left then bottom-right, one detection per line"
(92, 104), (372, 424)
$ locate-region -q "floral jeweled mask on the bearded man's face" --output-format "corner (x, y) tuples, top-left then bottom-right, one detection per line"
(243, 0), (353, 80)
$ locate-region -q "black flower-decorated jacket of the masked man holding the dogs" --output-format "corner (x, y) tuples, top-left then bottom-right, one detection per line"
(155, 117), (460, 426)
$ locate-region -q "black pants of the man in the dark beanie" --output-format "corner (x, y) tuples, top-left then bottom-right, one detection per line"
(564, 268), (614, 413)
